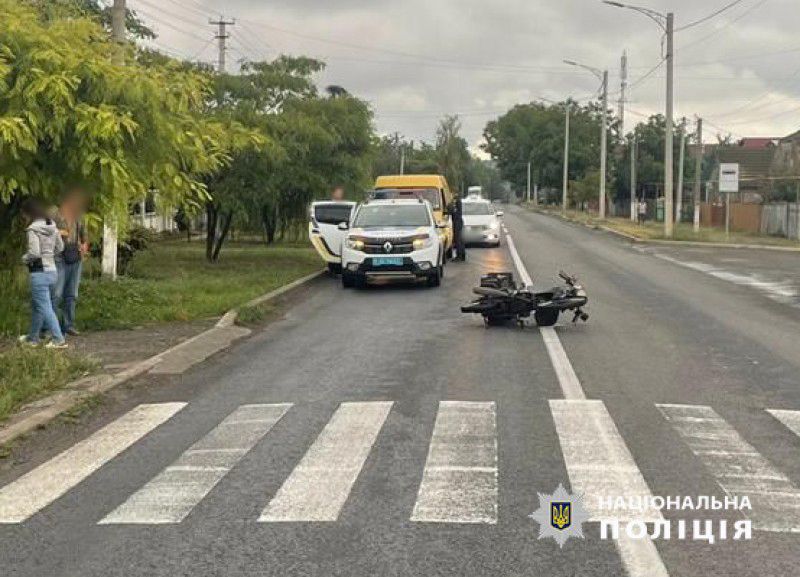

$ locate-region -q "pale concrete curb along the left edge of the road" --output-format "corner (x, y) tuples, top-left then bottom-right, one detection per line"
(0, 269), (325, 446)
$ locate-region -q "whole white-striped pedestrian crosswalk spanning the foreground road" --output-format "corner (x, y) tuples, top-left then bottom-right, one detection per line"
(0, 399), (800, 533)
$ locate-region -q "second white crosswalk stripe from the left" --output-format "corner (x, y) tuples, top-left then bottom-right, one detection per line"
(100, 404), (292, 525)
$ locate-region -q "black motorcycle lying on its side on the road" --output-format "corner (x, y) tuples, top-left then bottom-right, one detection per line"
(461, 271), (589, 327)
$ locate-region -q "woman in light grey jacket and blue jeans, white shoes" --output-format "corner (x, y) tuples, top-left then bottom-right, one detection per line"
(19, 199), (67, 349)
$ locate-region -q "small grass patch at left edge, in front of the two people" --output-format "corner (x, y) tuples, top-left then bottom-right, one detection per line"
(0, 347), (98, 422)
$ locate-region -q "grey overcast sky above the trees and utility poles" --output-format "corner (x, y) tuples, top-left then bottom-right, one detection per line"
(128, 0), (800, 147)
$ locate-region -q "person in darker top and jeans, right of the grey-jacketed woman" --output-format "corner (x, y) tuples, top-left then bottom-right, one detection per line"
(53, 193), (89, 336)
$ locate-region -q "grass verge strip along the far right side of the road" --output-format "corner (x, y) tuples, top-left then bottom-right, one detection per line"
(538, 209), (800, 248)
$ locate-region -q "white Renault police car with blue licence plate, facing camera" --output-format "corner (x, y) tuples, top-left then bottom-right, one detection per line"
(341, 199), (445, 288)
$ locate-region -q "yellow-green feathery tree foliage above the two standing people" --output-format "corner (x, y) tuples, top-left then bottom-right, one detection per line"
(0, 0), (244, 262)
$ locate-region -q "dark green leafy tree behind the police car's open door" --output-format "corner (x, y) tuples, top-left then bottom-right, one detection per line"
(206, 56), (374, 261)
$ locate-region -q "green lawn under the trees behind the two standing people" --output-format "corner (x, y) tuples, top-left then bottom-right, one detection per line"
(0, 240), (322, 335)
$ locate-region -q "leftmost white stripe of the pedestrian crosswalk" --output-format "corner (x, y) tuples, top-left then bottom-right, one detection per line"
(0, 403), (186, 523)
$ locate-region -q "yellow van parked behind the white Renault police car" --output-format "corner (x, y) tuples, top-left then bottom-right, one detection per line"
(372, 174), (454, 255)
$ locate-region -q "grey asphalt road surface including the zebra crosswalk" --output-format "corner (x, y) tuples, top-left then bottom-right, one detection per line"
(0, 208), (800, 577)
